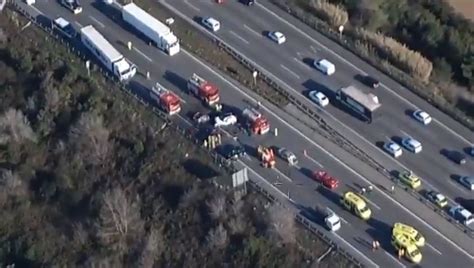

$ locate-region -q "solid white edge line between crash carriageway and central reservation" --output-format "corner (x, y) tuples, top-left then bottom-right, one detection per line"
(179, 49), (474, 259)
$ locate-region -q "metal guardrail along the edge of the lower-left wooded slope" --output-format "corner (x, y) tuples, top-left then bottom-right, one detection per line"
(8, 1), (363, 267)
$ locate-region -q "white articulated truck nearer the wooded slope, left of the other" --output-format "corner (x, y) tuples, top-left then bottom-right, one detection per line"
(81, 25), (137, 81)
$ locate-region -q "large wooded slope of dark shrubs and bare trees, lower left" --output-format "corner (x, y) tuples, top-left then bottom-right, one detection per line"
(0, 5), (352, 267)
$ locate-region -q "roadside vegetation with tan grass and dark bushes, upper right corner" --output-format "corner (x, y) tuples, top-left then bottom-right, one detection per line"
(270, 0), (474, 129)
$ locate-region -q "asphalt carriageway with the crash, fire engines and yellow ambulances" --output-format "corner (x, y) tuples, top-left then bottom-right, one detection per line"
(14, 1), (474, 267)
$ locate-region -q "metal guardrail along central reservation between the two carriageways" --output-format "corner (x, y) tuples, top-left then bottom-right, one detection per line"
(210, 25), (474, 238)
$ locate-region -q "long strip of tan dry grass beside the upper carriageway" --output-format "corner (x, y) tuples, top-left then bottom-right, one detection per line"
(356, 29), (433, 82)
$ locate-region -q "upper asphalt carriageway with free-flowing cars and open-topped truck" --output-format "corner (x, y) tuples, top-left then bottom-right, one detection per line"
(162, 0), (474, 201)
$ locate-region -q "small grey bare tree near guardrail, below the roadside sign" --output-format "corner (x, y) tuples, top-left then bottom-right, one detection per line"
(269, 205), (296, 244)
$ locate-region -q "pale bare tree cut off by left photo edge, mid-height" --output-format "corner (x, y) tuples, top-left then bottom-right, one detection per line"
(0, 108), (36, 144)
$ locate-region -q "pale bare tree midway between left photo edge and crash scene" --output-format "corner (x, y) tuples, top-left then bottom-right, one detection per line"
(70, 113), (111, 164)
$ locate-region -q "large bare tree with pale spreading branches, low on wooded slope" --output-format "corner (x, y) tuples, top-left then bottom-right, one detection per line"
(97, 188), (143, 251)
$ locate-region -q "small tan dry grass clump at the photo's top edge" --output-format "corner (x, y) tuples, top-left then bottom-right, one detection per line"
(311, 0), (349, 28)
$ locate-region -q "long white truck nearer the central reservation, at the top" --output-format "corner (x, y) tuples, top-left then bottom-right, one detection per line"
(122, 3), (179, 56)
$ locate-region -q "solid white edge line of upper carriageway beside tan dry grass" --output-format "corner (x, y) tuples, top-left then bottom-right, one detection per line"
(257, 3), (471, 145)
